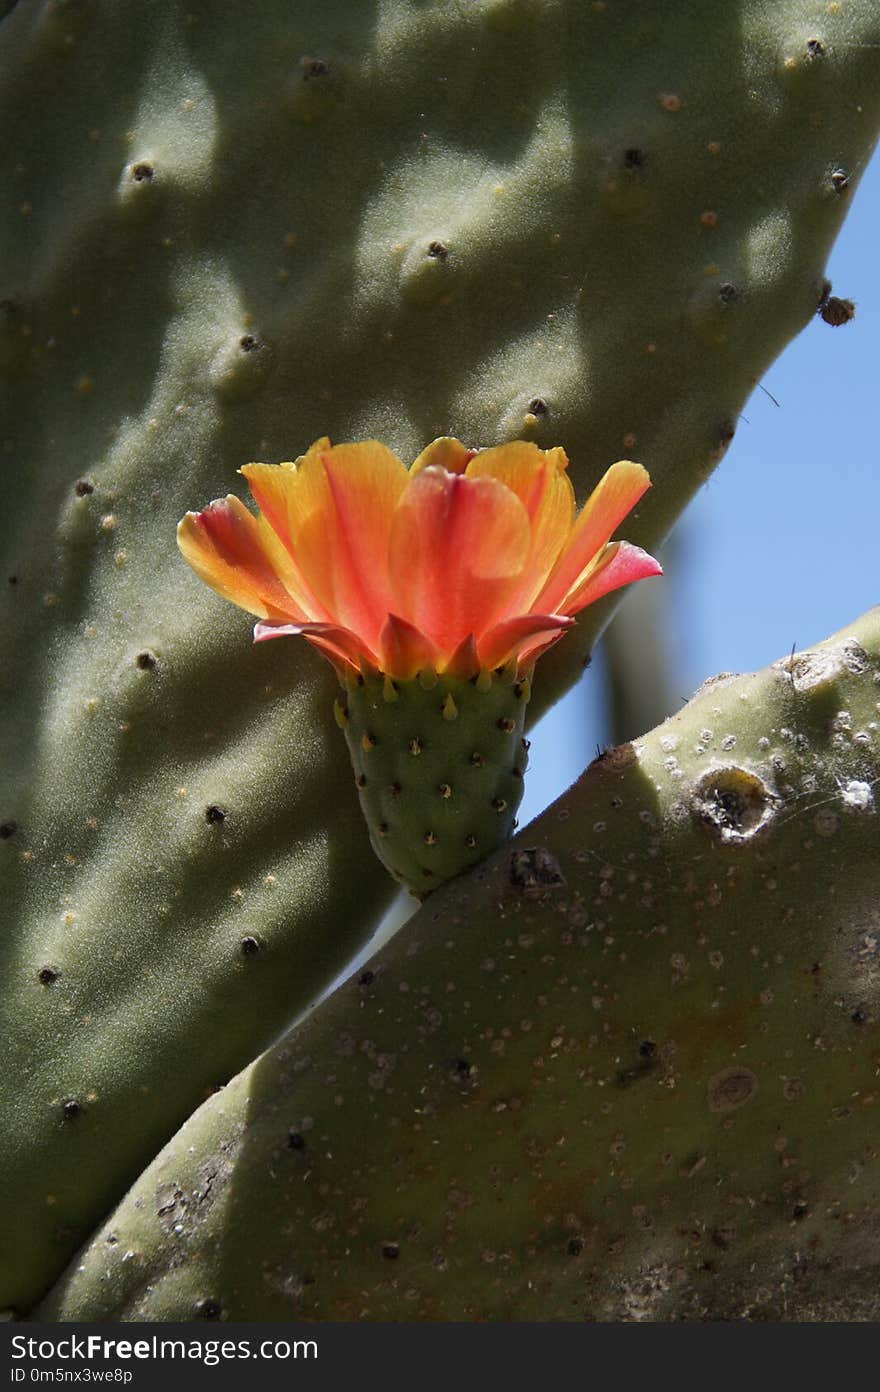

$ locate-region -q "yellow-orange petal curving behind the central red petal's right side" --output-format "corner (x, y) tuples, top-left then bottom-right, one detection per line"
(466, 440), (575, 614)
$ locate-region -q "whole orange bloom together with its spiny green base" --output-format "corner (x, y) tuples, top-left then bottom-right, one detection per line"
(178, 437), (660, 896)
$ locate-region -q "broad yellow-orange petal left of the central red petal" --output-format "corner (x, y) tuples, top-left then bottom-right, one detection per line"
(242, 440), (407, 646)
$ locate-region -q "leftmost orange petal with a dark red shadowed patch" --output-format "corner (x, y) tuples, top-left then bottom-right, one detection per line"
(177, 496), (305, 621)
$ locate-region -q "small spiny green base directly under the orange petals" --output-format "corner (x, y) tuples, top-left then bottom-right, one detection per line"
(336, 665), (531, 898)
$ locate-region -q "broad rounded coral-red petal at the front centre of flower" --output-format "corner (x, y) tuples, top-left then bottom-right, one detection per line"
(388, 465), (531, 657)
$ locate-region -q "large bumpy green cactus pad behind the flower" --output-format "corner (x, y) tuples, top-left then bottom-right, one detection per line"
(0, 0), (880, 1311)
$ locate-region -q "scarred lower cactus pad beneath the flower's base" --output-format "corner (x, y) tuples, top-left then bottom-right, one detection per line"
(40, 610), (880, 1321)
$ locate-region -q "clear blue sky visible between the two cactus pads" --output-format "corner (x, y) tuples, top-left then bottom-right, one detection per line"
(521, 141), (880, 825)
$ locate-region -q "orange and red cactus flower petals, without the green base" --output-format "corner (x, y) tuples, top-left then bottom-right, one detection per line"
(178, 438), (660, 681)
